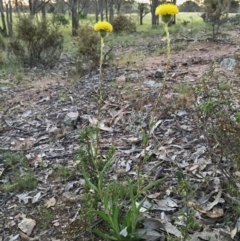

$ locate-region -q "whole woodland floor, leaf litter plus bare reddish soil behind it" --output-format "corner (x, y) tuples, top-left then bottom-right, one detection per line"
(0, 28), (240, 241)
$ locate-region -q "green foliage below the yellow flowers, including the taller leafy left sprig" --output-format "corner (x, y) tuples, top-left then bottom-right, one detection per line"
(75, 125), (164, 241)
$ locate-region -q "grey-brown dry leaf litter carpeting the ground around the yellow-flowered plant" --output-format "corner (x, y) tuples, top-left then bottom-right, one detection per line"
(0, 34), (239, 241)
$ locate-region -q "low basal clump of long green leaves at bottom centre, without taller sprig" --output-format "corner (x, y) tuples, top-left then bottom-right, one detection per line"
(83, 150), (164, 241)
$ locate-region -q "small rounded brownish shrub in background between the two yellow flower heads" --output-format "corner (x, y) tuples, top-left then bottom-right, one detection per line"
(112, 15), (136, 33)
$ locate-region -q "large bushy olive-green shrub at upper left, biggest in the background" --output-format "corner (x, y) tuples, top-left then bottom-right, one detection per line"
(8, 16), (63, 67)
